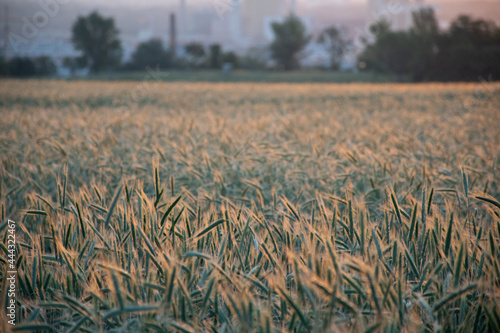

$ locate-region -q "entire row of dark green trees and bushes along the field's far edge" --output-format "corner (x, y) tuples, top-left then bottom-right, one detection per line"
(0, 8), (500, 82)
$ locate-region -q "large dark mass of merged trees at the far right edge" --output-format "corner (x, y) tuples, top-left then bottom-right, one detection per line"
(359, 8), (500, 82)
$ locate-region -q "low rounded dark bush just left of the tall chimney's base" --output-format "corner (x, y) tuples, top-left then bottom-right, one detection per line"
(127, 38), (171, 70)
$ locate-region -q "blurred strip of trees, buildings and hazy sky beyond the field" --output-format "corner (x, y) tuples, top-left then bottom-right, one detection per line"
(0, 0), (500, 82)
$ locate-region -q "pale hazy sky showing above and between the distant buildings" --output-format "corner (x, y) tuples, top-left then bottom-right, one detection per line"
(0, 0), (500, 57)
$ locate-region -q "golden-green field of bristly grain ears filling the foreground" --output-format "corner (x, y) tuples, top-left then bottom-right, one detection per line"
(0, 80), (500, 332)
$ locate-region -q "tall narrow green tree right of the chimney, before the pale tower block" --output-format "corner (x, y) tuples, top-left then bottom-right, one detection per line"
(271, 15), (311, 70)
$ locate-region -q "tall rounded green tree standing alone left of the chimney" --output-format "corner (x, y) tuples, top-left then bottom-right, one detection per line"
(71, 12), (122, 73)
